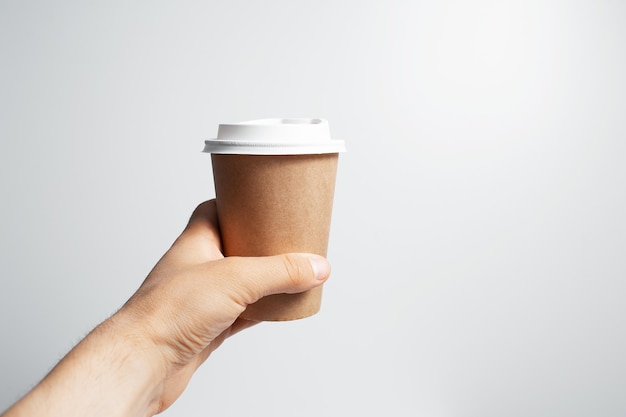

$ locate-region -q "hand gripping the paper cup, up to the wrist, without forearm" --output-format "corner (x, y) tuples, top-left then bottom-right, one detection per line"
(120, 200), (330, 409)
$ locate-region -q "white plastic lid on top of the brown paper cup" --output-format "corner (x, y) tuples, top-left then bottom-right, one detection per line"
(203, 119), (346, 155)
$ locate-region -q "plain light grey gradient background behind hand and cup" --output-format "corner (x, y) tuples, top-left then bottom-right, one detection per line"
(0, 0), (626, 417)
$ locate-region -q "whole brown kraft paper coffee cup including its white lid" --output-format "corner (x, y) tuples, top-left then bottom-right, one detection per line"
(204, 119), (345, 321)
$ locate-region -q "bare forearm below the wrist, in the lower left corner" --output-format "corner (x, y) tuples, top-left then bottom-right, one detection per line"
(3, 316), (165, 417)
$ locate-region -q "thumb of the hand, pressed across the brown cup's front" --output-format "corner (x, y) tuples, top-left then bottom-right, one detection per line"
(219, 253), (330, 305)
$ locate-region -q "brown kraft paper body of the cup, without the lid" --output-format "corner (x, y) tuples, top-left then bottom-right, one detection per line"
(211, 153), (338, 321)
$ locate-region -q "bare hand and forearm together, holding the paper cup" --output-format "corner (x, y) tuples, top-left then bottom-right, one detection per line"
(0, 200), (330, 417)
